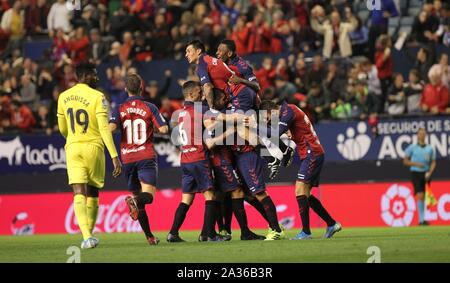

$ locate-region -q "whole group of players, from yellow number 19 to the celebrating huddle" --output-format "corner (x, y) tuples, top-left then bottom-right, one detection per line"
(58, 40), (342, 248)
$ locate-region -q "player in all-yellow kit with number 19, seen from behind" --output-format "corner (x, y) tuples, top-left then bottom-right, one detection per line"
(58, 64), (122, 249)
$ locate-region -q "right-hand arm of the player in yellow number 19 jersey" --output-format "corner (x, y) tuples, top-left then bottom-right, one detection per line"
(95, 95), (122, 177)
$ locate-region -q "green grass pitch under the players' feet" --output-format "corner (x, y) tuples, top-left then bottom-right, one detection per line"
(0, 226), (450, 263)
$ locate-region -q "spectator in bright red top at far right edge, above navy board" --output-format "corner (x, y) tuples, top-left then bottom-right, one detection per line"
(420, 74), (449, 114)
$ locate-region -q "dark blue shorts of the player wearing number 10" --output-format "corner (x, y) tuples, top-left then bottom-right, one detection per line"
(123, 159), (158, 192)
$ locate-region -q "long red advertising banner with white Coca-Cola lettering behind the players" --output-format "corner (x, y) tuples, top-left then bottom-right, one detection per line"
(0, 182), (450, 235)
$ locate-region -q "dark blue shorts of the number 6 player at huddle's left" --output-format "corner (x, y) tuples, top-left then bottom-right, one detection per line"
(181, 160), (213, 194)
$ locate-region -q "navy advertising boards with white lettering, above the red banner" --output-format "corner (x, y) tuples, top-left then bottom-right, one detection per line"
(0, 115), (450, 173)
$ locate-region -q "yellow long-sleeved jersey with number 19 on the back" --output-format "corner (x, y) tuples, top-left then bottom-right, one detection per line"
(58, 83), (117, 158)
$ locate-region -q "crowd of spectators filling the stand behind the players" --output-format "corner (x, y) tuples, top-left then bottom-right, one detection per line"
(0, 0), (450, 134)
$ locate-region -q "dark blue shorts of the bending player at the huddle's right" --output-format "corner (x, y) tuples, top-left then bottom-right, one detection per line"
(297, 154), (325, 187)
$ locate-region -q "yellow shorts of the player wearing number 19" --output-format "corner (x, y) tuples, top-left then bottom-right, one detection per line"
(66, 143), (105, 189)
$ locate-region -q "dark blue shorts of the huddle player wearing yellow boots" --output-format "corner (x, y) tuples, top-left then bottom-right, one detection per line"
(235, 151), (266, 195)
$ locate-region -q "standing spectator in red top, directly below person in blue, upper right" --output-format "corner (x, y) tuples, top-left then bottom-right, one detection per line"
(375, 34), (394, 113)
